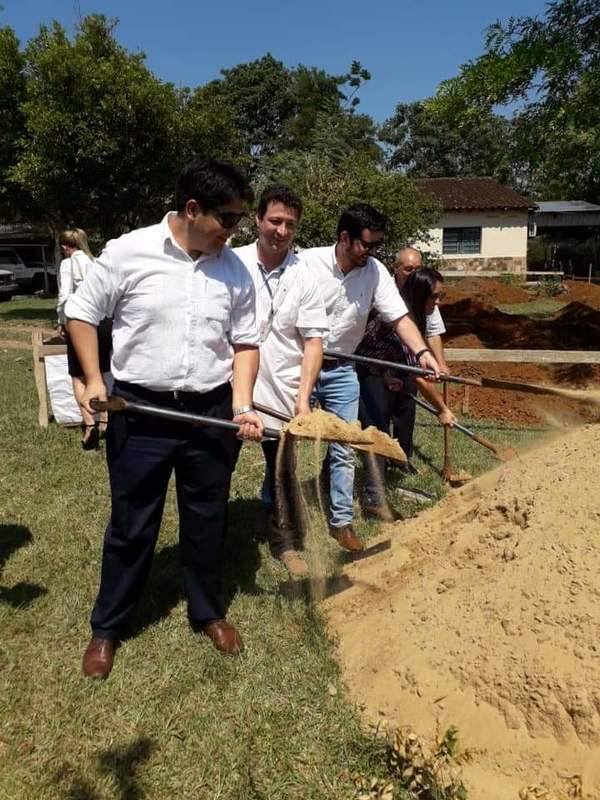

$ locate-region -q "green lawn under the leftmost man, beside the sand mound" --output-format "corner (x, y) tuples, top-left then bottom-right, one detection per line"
(0, 299), (538, 800)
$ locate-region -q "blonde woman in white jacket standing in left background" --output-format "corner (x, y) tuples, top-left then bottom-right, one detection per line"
(56, 228), (111, 450)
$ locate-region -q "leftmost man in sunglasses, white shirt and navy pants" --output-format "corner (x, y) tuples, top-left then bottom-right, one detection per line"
(65, 159), (263, 678)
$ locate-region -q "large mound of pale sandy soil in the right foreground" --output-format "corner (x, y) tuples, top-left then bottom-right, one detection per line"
(325, 425), (600, 800)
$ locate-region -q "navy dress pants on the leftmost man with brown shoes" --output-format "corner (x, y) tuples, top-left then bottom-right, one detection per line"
(91, 381), (236, 639)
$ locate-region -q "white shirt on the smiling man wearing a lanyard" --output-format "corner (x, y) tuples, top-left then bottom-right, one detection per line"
(233, 242), (328, 427)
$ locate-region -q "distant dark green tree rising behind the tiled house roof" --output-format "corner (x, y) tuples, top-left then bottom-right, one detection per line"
(379, 102), (516, 184)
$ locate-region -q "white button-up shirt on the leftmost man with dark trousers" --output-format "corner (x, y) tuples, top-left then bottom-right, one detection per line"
(65, 212), (259, 392)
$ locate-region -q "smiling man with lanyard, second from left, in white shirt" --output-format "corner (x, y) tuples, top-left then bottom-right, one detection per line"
(234, 185), (328, 576)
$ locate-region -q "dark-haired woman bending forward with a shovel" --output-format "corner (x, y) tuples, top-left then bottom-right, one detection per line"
(356, 267), (455, 522)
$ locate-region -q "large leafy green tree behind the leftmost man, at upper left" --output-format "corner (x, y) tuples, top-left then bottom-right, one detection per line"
(11, 15), (183, 239)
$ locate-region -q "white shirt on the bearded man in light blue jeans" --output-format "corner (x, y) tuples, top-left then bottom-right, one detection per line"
(300, 245), (408, 354)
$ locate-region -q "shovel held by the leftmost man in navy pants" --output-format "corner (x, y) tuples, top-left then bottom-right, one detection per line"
(90, 395), (372, 446)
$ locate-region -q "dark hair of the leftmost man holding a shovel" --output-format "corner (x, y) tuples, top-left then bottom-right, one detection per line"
(175, 158), (252, 211)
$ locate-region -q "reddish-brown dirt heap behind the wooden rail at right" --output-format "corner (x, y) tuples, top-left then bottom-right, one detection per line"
(442, 278), (600, 432)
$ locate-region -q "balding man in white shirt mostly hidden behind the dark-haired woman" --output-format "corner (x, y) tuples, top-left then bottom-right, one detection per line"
(388, 247), (449, 466)
